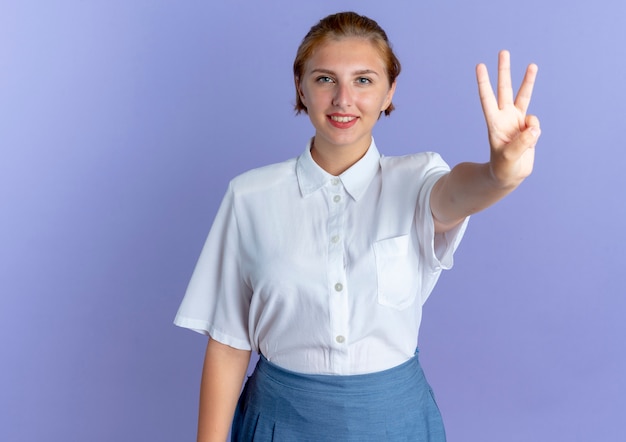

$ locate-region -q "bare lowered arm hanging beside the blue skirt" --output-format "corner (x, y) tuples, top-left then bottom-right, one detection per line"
(198, 339), (250, 442)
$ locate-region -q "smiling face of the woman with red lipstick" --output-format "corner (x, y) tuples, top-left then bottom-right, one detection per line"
(297, 37), (396, 157)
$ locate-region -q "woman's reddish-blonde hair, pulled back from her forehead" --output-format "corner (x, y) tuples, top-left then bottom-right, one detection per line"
(293, 12), (401, 115)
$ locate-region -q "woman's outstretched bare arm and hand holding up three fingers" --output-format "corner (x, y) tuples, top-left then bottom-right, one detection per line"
(430, 51), (541, 232)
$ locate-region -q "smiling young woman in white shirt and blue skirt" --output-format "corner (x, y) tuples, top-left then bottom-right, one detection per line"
(175, 12), (540, 441)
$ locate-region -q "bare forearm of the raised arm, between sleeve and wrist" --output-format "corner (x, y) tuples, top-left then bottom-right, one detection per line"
(430, 163), (523, 232)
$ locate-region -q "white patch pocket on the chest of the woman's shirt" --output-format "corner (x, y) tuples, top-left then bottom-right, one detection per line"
(374, 235), (418, 310)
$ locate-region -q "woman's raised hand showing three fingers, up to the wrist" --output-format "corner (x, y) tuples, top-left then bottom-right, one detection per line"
(476, 51), (541, 187)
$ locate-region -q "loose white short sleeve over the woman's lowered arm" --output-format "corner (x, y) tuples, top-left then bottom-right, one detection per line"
(174, 183), (251, 350)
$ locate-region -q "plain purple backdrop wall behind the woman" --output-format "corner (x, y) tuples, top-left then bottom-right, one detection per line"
(0, 0), (626, 442)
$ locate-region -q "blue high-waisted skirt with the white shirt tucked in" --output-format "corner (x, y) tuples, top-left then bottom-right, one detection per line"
(231, 354), (446, 442)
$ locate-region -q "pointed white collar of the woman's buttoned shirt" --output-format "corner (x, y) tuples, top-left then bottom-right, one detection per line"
(296, 138), (380, 200)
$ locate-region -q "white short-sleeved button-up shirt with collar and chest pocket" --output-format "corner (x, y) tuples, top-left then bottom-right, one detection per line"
(174, 140), (467, 375)
